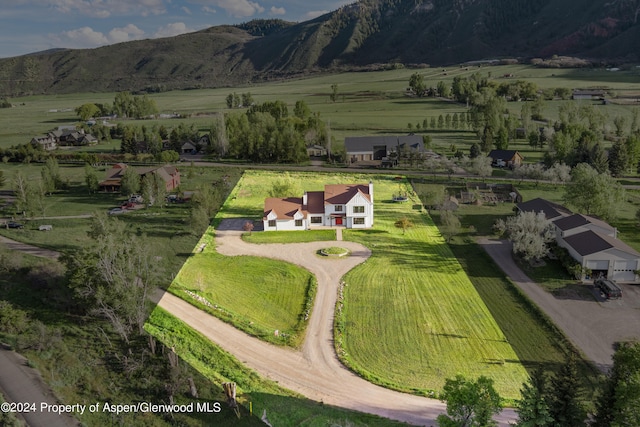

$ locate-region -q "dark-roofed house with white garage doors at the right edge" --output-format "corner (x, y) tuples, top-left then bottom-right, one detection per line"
(518, 199), (640, 283)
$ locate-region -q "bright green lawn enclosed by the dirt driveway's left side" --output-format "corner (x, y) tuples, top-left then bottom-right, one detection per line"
(169, 229), (316, 347)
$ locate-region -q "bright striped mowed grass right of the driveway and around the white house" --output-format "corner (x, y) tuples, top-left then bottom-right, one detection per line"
(206, 171), (527, 398)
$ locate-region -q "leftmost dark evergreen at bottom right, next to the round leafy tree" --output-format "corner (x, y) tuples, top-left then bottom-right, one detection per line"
(516, 368), (553, 427)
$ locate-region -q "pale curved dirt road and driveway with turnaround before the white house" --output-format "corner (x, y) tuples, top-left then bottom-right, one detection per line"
(158, 220), (516, 426)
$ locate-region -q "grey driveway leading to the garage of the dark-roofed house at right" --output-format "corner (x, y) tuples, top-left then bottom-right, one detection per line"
(479, 238), (640, 371)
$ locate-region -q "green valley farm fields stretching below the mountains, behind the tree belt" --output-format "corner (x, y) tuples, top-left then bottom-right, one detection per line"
(0, 65), (640, 166)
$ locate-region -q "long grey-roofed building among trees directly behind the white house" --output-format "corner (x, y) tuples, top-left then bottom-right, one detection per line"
(344, 135), (424, 163)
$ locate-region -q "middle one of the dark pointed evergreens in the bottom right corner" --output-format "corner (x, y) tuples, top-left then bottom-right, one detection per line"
(549, 353), (586, 427)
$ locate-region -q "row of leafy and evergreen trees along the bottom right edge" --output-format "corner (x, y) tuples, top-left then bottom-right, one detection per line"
(437, 342), (640, 427)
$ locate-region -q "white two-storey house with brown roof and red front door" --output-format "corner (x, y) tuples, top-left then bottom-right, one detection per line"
(262, 182), (373, 231)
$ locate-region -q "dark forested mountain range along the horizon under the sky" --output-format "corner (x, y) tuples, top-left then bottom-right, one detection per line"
(0, 0), (640, 96)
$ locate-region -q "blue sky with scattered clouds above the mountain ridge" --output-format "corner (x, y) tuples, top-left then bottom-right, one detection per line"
(0, 0), (355, 58)
